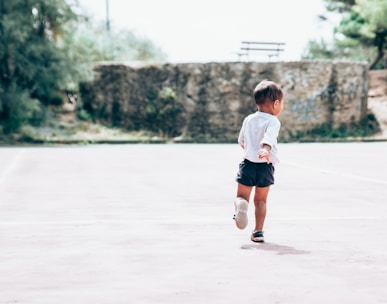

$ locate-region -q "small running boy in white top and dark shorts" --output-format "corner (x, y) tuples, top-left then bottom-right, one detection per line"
(234, 80), (284, 242)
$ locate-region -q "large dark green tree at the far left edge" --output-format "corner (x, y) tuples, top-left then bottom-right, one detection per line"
(0, 0), (83, 133)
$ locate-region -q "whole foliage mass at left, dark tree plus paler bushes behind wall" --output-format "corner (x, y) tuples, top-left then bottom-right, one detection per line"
(0, 0), (166, 133)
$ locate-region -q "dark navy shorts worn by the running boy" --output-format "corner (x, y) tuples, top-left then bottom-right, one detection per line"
(235, 159), (274, 187)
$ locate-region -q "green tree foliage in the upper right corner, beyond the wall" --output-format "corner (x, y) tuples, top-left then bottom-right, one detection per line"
(303, 0), (387, 69)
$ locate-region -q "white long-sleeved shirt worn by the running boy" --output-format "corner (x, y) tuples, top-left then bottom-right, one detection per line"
(238, 111), (281, 166)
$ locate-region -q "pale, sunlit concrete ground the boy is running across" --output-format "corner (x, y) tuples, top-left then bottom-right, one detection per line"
(0, 142), (387, 304)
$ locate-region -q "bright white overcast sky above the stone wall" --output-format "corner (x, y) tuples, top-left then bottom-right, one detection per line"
(78, 0), (333, 63)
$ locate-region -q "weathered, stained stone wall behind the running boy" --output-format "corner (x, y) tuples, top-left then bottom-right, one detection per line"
(80, 61), (368, 141)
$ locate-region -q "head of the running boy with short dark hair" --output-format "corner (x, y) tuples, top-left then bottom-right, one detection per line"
(254, 80), (284, 116)
